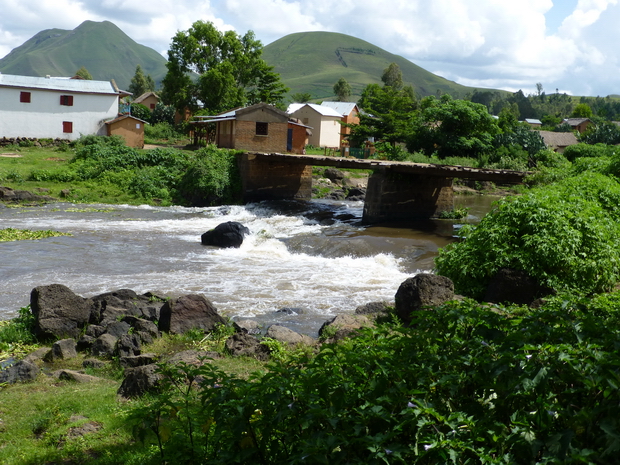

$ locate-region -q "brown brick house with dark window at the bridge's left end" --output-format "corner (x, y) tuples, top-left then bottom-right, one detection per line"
(192, 103), (311, 153)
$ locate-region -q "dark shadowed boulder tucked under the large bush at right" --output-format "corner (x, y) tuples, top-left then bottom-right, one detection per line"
(484, 268), (554, 305)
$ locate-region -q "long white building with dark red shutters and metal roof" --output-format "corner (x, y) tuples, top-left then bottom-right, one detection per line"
(0, 74), (119, 140)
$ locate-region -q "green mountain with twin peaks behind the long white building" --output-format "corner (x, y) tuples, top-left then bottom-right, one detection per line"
(0, 21), (167, 89)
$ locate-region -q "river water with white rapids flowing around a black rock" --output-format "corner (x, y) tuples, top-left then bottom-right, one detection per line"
(0, 196), (493, 336)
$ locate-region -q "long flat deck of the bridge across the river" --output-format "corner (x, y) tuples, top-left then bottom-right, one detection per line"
(247, 153), (529, 184)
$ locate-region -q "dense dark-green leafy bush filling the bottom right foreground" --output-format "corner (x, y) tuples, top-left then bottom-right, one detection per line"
(131, 295), (620, 464)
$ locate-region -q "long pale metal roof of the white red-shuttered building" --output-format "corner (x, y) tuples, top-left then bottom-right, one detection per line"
(0, 74), (118, 95)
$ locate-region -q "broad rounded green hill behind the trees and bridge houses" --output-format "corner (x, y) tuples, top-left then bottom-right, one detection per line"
(263, 32), (498, 101)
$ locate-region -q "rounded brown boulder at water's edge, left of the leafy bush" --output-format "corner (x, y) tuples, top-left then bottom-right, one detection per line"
(394, 273), (454, 322)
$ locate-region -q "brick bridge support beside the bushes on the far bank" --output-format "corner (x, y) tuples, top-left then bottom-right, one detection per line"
(238, 153), (312, 202)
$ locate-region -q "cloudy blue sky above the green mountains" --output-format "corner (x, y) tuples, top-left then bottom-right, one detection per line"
(0, 0), (620, 96)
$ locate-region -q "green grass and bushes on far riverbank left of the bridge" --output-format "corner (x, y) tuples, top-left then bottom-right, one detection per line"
(0, 135), (245, 206)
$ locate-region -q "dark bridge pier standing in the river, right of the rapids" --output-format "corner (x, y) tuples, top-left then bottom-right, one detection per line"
(362, 169), (454, 224)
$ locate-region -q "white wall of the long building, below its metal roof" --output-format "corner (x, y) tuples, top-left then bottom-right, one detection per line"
(0, 87), (118, 140)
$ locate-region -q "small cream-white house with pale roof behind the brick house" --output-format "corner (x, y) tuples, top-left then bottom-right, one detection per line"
(287, 103), (342, 148)
